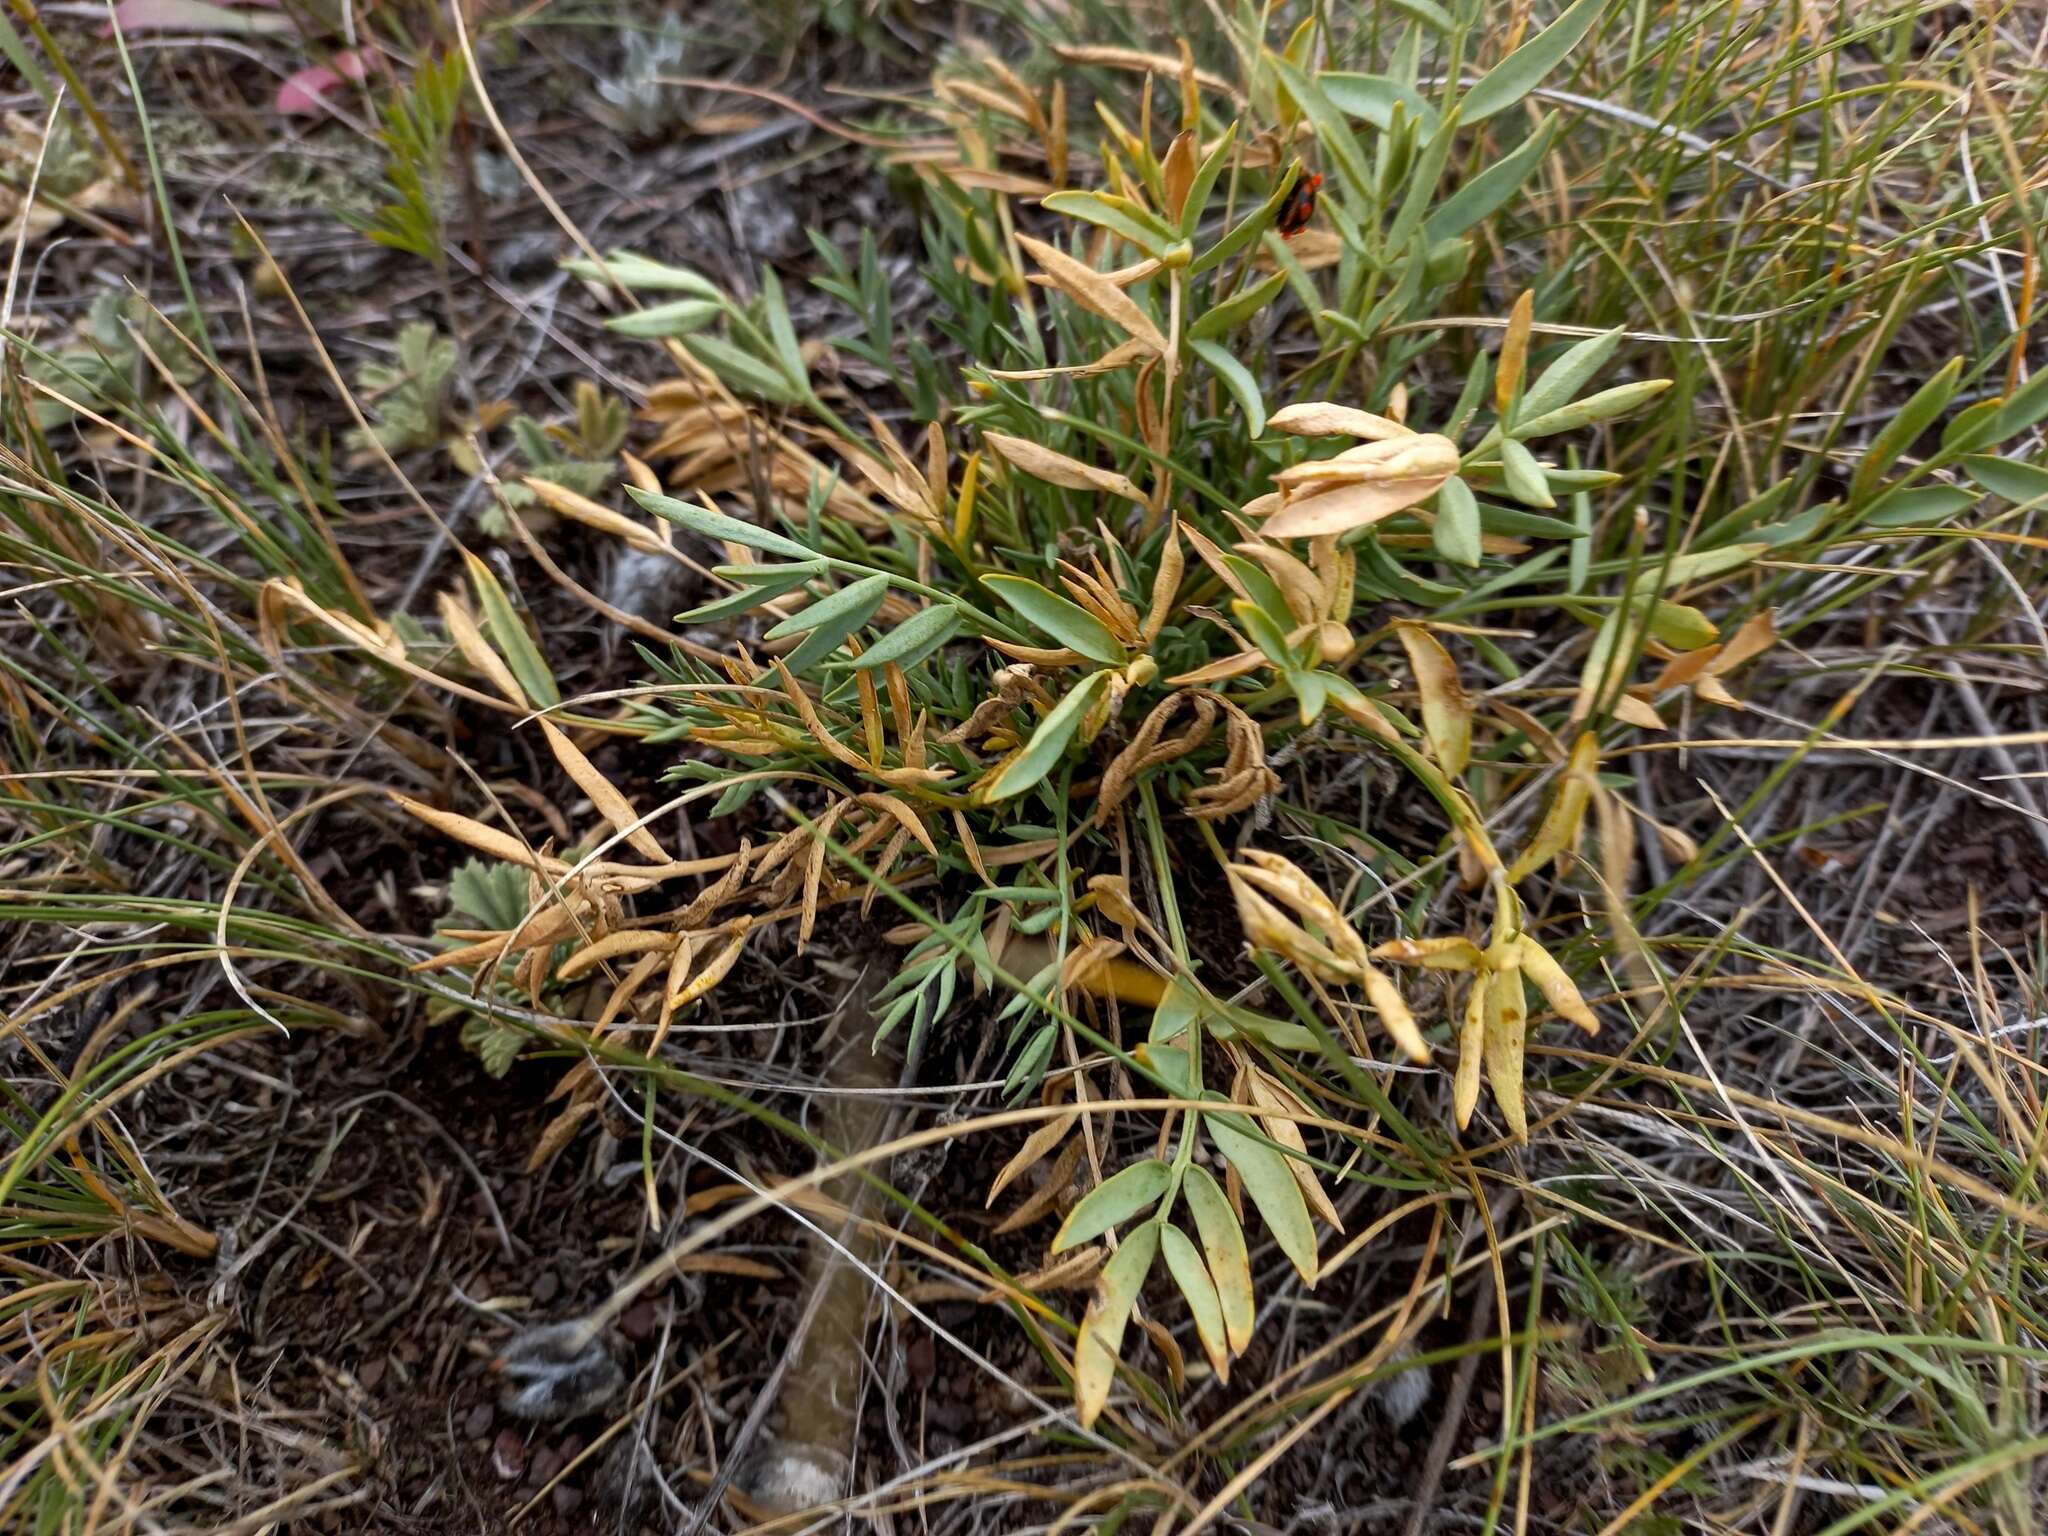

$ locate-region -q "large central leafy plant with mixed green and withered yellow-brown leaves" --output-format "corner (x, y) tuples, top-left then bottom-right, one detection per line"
(507, 12), (2048, 1421)
